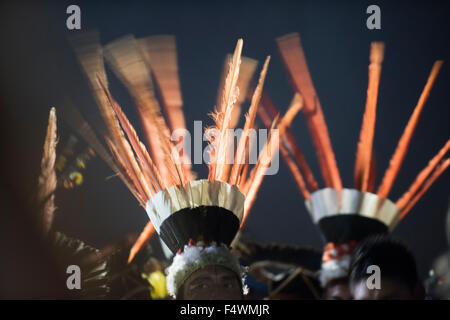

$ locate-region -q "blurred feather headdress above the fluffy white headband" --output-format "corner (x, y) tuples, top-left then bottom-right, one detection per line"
(71, 36), (296, 294)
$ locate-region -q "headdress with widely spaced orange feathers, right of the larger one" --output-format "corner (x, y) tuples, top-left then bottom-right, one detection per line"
(268, 33), (450, 283)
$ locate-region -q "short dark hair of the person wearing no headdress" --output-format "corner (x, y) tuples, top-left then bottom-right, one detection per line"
(350, 235), (419, 290)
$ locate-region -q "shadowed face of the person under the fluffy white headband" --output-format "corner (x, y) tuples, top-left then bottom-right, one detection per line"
(182, 266), (242, 300)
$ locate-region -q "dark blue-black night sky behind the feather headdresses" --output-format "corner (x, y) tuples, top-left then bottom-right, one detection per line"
(0, 1), (450, 296)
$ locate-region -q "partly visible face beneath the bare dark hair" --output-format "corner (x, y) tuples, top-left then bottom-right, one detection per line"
(353, 278), (415, 300)
